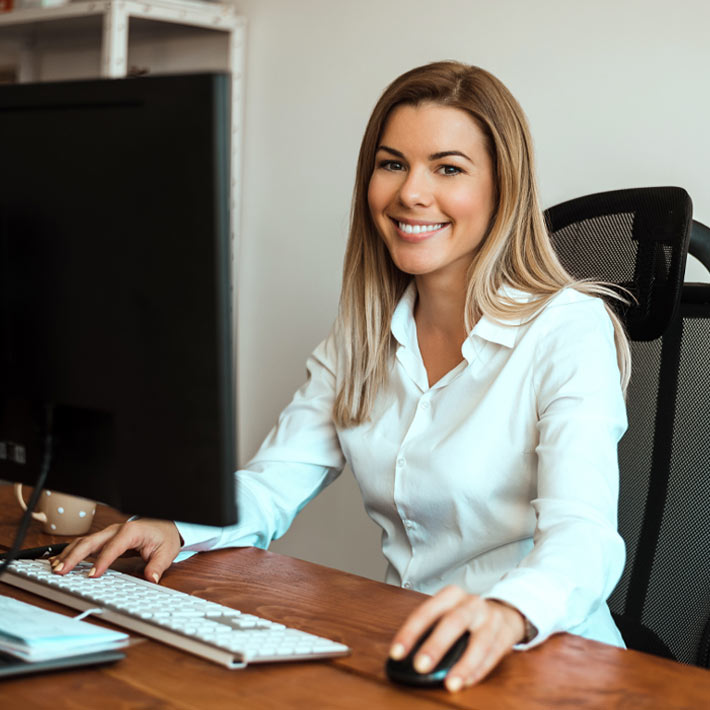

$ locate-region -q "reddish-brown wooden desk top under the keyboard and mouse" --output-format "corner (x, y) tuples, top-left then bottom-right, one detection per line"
(0, 486), (710, 710)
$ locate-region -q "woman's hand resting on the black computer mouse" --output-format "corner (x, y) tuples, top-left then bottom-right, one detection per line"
(390, 586), (525, 691)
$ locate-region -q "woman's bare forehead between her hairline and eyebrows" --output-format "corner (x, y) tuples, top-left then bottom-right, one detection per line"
(379, 103), (486, 153)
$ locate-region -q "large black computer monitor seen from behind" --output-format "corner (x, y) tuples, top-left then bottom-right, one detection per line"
(0, 74), (236, 525)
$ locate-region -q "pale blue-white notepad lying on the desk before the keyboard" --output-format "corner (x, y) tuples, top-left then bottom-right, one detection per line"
(0, 595), (129, 661)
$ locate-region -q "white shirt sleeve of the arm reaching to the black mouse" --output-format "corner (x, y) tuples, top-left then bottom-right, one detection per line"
(485, 299), (626, 648)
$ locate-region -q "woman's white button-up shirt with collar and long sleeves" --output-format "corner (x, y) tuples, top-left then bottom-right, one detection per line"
(178, 284), (626, 645)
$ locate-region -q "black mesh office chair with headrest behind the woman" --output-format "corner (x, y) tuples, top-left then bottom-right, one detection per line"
(545, 187), (710, 668)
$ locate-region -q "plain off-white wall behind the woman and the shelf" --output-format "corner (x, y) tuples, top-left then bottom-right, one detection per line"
(0, 0), (710, 578)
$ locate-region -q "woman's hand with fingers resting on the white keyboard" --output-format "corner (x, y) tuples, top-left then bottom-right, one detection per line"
(50, 518), (182, 584)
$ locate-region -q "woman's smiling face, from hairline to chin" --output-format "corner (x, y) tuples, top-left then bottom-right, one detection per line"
(368, 103), (495, 290)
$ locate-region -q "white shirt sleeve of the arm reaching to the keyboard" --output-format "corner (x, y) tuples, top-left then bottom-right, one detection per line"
(176, 337), (345, 561)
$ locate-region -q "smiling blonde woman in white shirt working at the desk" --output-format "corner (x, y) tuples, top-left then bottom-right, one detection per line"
(53, 62), (629, 690)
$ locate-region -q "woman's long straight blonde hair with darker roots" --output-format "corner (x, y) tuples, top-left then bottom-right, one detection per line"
(334, 62), (631, 427)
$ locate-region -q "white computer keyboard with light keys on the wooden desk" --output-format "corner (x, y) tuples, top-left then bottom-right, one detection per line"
(0, 560), (350, 668)
